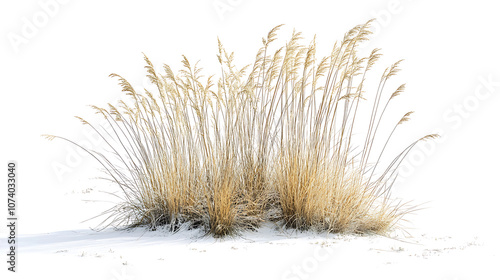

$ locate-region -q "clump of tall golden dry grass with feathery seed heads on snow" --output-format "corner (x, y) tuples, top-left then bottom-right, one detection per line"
(47, 21), (435, 237)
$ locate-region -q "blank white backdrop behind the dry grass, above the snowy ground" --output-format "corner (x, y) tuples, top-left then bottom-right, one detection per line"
(0, 0), (500, 278)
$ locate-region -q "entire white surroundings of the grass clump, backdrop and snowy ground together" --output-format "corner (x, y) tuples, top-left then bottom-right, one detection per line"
(0, 0), (500, 280)
